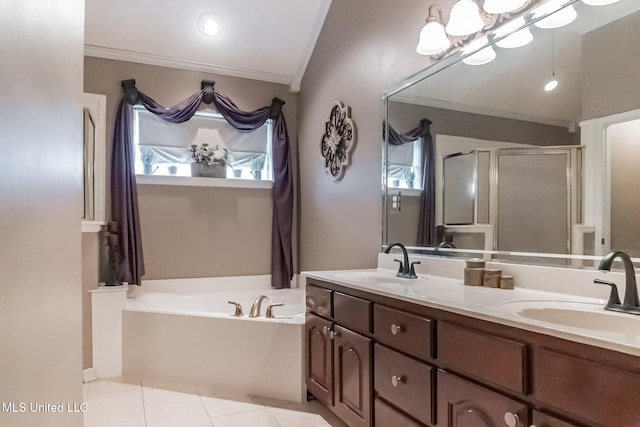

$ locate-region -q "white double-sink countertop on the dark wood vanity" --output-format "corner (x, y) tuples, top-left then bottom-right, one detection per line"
(302, 268), (640, 356)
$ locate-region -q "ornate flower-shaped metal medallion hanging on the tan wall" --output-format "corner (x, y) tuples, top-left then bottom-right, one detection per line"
(320, 101), (356, 180)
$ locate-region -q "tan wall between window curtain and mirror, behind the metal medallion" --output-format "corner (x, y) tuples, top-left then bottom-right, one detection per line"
(299, 0), (440, 270)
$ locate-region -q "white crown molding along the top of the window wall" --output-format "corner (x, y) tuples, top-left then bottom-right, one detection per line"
(84, 44), (299, 92)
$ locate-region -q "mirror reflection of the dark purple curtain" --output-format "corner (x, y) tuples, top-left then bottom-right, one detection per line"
(389, 119), (436, 246)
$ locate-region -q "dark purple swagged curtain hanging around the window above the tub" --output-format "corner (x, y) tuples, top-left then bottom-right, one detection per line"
(111, 80), (293, 288)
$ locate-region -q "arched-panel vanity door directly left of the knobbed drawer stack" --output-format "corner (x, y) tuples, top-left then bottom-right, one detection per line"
(333, 325), (371, 427)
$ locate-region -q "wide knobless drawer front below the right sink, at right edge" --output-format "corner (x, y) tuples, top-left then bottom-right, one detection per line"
(534, 349), (640, 427)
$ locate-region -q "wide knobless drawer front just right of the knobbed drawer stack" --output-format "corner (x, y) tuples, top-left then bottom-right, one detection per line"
(438, 322), (526, 393)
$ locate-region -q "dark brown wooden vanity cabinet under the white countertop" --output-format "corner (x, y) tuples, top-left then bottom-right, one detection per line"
(305, 278), (640, 427)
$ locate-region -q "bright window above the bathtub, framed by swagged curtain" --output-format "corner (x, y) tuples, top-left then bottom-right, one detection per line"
(133, 106), (273, 180)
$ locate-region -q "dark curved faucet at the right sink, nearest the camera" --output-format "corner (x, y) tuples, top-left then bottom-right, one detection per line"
(594, 251), (640, 315)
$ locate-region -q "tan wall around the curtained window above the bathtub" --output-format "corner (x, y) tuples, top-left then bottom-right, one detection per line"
(84, 57), (298, 279)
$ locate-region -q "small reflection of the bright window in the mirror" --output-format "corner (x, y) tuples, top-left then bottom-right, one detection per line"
(387, 139), (422, 190)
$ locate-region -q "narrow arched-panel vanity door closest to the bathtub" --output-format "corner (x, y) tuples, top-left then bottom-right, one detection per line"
(305, 313), (333, 406)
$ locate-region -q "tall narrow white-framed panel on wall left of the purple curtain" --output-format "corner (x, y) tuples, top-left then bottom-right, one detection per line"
(82, 93), (107, 232)
